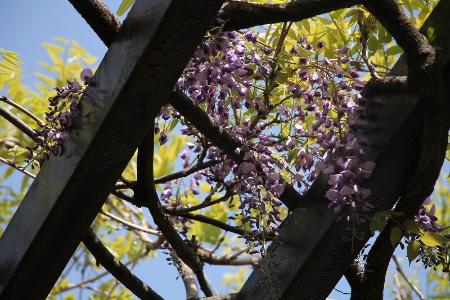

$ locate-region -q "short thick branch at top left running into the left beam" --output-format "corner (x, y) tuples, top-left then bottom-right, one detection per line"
(69, 0), (120, 47)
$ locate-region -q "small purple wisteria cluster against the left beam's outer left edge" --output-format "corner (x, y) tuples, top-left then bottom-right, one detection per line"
(34, 69), (93, 161)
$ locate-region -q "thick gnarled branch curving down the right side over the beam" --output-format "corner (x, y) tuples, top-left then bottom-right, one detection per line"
(356, 0), (449, 299)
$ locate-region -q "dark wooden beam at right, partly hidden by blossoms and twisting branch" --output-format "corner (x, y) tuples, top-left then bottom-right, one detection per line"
(238, 1), (450, 299)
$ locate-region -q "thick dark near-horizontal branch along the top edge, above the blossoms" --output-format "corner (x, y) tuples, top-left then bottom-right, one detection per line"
(221, 0), (361, 31)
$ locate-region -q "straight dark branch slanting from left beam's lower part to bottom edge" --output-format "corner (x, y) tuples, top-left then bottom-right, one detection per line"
(83, 229), (163, 300)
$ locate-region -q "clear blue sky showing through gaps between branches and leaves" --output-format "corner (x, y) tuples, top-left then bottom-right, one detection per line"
(0, 0), (440, 299)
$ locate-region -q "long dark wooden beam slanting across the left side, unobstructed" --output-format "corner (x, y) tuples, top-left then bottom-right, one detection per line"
(0, 0), (223, 300)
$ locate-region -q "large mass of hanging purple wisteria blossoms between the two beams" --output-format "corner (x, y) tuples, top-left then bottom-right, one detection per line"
(157, 25), (375, 237)
